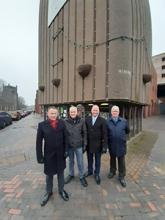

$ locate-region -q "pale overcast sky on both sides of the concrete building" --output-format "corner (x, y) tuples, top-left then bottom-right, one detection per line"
(0, 0), (165, 105)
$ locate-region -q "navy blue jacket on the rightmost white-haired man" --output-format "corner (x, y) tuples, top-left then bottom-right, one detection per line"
(107, 117), (130, 157)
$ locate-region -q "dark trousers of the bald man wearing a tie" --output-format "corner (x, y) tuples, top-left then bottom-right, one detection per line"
(87, 151), (101, 176)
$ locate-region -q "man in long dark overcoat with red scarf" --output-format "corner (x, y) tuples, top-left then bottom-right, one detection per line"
(36, 107), (69, 206)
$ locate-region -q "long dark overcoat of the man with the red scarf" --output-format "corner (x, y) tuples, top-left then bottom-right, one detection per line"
(36, 119), (68, 175)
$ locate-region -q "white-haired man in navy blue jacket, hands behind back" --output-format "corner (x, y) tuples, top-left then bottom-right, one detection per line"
(107, 106), (130, 187)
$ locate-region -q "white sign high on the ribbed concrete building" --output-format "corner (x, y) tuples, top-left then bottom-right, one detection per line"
(48, 0), (67, 26)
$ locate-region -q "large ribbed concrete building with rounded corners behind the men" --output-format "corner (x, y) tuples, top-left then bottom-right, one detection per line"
(38, 0), (155, 135)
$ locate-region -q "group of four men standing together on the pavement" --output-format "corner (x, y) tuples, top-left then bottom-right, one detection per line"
(36, 105), (129, 206)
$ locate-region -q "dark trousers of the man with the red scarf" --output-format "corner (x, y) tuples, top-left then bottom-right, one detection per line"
(46, 171), (64, 193)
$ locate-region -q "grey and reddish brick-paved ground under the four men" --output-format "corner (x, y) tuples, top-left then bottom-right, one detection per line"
(0, 115), (165, 220)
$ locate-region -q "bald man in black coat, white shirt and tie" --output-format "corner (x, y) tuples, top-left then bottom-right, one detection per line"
(86, 105), (107, 185)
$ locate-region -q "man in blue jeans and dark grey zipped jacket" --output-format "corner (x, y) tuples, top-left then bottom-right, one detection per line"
(65, 106), (88, 187)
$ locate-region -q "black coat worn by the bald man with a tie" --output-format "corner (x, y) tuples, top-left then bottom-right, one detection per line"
(86, 116), (107, 153)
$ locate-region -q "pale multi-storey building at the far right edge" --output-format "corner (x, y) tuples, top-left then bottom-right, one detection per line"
(152, 53), (165, 114)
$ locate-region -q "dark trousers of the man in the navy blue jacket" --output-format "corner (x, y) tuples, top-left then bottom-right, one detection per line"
(110, 154), (126, 178)
